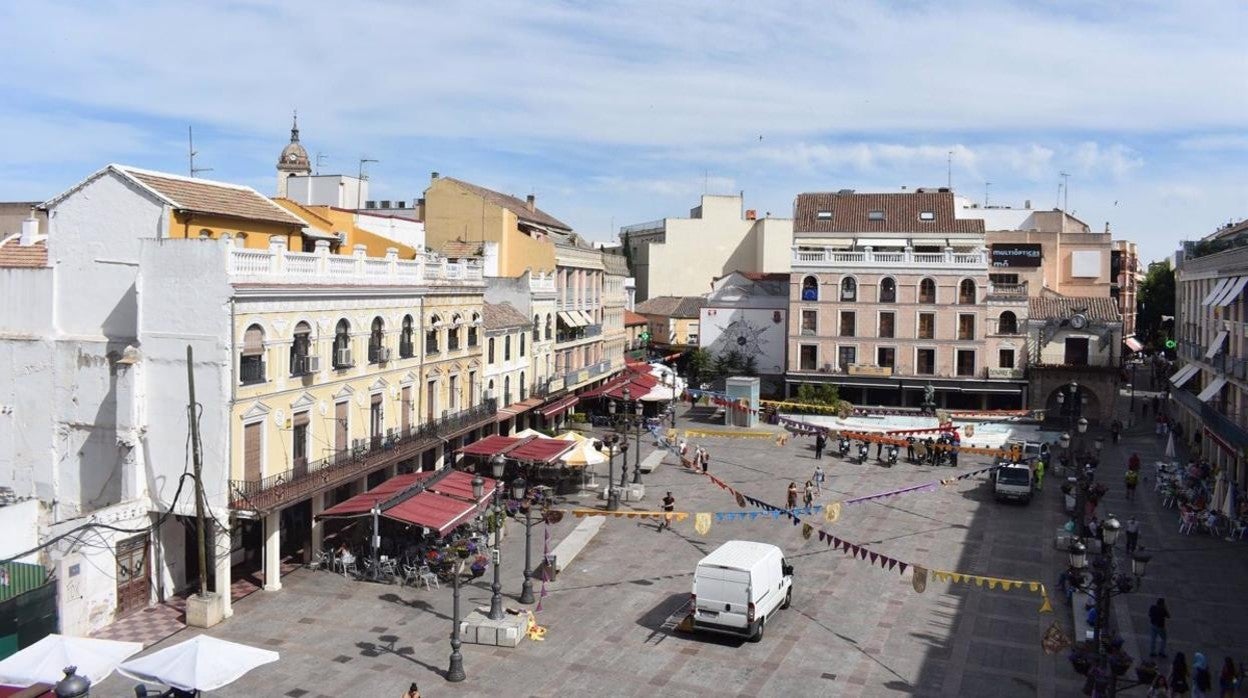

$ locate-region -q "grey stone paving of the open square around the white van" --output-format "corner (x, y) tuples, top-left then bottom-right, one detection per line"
(94, 399), (1248, 698)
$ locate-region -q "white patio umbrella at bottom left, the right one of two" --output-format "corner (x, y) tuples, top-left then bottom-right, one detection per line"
(117, 636), (278, 691)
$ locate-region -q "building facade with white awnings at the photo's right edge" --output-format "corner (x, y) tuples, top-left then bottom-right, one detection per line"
(1169, 221), (1248, 489)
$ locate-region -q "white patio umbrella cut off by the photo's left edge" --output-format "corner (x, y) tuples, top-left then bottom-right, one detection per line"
(0, 633), (144, 686)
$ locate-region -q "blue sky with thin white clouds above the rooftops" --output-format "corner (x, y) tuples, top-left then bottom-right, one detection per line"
(0, 0), (1248, 260)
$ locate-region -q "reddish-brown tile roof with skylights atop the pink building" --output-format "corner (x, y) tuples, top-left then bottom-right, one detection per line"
(792, 191), (983, 233)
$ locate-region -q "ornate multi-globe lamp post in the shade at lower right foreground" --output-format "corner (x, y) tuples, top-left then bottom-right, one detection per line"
(1067, 514), (1152, 697)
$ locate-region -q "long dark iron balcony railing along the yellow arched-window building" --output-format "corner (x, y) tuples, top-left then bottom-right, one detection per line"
(230, 400), (498, 512)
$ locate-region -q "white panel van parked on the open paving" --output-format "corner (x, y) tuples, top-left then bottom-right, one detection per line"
(693, 541), (792, 642)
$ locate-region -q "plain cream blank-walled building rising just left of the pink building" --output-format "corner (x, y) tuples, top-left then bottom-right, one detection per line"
(619, 195), (794, 303)
